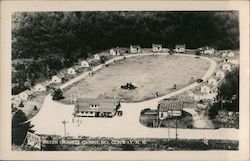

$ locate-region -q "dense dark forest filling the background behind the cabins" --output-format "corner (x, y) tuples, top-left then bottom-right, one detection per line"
(12, 11), (239, 94)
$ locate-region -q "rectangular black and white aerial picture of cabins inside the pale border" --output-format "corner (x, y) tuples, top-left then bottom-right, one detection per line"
(1, 2), (249, 159)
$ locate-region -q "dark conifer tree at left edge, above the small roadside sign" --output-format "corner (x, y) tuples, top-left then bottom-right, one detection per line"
(12, 110), (34, 145)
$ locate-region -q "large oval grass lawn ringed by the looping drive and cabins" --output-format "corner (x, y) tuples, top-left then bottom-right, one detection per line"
(63, 55), (209, 103)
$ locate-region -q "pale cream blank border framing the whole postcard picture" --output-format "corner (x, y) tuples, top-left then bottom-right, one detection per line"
(0, 1), (249, 160)
